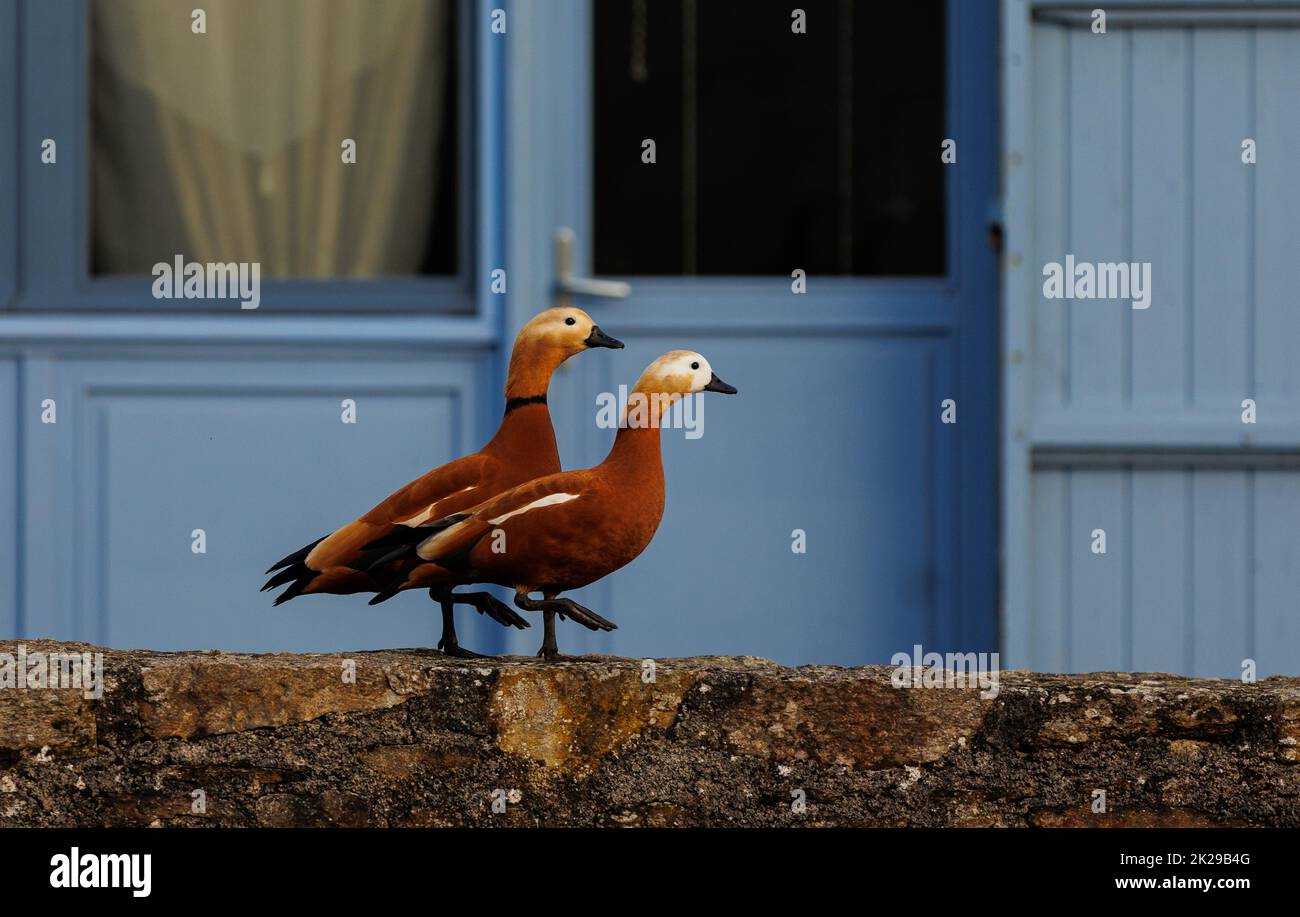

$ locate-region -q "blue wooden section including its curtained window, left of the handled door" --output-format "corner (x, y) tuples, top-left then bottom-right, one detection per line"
(0, 0), (504, 650)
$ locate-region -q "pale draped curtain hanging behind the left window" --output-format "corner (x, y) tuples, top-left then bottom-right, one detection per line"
(91, 0), (454, 277)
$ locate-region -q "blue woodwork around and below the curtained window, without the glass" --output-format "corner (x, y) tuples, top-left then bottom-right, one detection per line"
(0, 0), (507, 650)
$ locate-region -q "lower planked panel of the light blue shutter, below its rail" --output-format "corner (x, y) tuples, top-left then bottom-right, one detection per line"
(1032, 470), (1300, 678)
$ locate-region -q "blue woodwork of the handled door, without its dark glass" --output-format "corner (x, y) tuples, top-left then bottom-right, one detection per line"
(510, 0), (997, 663)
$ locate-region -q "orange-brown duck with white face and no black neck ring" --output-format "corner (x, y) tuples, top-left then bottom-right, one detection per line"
(371, 350), (736, 659)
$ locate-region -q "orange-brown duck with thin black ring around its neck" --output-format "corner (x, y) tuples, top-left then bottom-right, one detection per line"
(263, 307), (623, 657)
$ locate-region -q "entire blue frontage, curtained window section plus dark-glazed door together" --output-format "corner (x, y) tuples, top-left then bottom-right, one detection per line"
(0, 0), (997, 663)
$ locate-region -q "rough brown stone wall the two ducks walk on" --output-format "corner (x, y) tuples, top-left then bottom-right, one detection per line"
(0, 641), (1300, 827)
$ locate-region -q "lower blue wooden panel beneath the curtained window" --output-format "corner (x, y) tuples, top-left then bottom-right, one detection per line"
(20, 349), (489, 650)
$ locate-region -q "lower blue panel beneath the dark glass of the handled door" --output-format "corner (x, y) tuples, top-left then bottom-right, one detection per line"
(538, 334), (953, 665)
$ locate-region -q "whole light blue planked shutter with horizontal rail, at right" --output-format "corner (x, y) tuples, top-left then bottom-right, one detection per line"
(1002, 0), (1300, 678)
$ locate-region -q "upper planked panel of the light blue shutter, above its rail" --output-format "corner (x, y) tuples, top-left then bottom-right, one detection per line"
(1032, 23), (1300, 418)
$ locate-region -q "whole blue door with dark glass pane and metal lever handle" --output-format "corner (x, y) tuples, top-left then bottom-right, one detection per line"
(493, 0), (997, 663)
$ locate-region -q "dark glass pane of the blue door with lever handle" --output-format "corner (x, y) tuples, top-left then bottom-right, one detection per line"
(593, 0), (946, 276)
